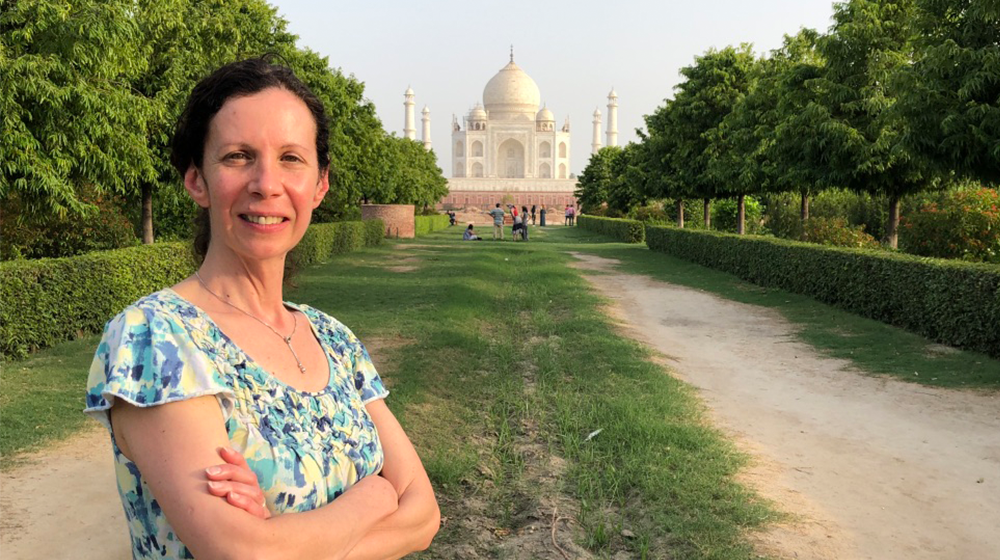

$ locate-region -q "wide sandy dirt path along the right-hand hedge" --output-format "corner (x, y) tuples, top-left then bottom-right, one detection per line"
(574, 253), (1000, 560)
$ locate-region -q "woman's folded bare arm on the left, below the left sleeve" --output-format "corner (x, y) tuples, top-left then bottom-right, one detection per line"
(112, 396), (399, 560)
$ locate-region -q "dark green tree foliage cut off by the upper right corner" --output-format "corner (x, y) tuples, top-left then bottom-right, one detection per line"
(896, 0), (1000, 184)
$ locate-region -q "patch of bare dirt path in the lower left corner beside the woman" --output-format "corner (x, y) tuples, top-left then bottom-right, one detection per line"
(0, 423), (132, 560)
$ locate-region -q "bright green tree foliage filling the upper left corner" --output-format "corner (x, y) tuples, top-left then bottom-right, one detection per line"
(0, 0), (155, 221)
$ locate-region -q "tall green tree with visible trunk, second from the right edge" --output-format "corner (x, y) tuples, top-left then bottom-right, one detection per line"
(811, 0), (938, 248)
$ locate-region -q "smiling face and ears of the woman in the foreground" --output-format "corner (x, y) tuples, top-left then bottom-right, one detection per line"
(184, 88), (330, 260)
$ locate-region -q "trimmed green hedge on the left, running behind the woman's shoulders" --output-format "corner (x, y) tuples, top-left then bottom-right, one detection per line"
(0, 220), (384, 359)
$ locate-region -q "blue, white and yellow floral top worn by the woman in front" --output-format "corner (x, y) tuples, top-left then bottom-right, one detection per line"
(85, 289), (388, 558)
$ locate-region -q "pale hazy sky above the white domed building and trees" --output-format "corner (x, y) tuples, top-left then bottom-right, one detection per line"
(271, 0), (833, 177)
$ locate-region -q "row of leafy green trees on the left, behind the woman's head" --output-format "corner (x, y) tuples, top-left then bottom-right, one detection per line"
(0, 0), (447, 256)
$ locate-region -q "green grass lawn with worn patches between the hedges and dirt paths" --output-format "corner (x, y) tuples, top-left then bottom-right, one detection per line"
(0, 222), (1000, 559)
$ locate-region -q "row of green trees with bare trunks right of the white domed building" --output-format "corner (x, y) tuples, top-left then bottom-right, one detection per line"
(577, 0), (1000, 248)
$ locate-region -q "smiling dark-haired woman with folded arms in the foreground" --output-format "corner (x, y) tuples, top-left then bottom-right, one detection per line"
(86, 59), (439, 560)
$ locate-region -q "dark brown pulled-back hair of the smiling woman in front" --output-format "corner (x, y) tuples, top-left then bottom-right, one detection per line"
(170, 55), (330, 262)
